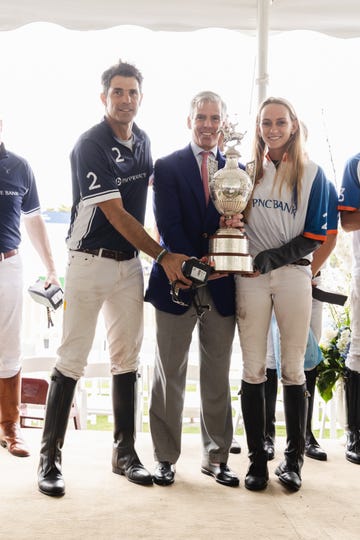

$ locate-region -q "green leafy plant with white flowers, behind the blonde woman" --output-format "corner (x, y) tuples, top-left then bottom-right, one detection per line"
(317, 304), (351, 402)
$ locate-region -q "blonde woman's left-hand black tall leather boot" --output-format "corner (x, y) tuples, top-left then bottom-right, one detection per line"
(241, 381), (269, 491)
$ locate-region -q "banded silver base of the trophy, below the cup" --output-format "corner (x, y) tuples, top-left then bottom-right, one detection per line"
(208, 228), (254, 274)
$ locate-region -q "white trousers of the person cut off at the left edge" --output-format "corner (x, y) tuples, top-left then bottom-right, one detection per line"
(0, 254), (23, 378)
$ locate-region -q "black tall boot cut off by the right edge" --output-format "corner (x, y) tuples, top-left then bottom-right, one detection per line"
(345, 368), (360, 465)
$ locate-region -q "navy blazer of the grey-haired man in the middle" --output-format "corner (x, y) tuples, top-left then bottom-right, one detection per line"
(145, 144), (235, 316)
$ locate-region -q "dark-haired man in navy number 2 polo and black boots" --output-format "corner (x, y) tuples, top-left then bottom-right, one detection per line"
(38, 61), (190, 496)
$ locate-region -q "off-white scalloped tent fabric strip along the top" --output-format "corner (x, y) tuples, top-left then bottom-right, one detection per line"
(0, 0), (360, 38)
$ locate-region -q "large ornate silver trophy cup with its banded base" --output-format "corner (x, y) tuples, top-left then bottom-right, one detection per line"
(208, 123), (255, 274)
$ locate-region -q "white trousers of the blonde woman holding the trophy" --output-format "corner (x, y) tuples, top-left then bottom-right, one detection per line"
(236, 265), (312, 385)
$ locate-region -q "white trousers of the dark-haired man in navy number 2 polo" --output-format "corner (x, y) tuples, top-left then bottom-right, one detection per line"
(56, 251), (144, 379)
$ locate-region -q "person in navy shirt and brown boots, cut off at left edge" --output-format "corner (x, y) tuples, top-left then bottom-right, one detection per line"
(0, 119), (59, 457)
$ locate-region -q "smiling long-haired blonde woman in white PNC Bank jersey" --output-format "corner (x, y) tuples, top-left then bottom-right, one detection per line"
(236, 97), (328, 490)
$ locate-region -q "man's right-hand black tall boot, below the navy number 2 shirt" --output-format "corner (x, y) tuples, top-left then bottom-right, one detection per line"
(112, 372), (153, 486)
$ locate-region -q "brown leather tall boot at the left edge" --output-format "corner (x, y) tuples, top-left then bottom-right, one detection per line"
(0, 371), (30, 457)
